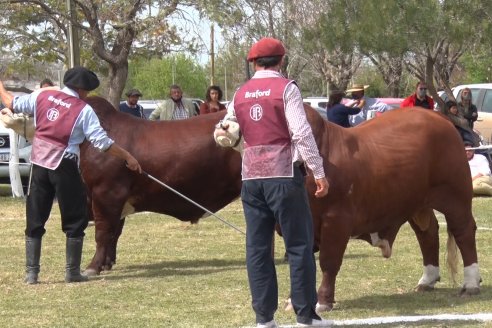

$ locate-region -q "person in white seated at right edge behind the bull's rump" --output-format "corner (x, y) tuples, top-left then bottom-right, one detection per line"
(465, 142), (492, 196)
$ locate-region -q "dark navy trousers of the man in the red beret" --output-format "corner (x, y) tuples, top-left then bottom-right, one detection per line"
(241, 167), (319, 323)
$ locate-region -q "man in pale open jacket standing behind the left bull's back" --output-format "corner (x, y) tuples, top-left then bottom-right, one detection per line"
(149, 84), (196, 121)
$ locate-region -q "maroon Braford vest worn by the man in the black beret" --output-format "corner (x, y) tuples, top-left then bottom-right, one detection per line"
(31, 90), (86, 170)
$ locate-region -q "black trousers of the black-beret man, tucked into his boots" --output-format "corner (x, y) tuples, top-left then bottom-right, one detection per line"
(25, 159), (88, 238)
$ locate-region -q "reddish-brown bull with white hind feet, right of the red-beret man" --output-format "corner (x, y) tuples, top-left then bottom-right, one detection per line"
(306, 109), (480, 311)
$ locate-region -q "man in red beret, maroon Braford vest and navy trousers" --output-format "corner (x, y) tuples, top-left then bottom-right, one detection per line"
(217, 38), (330, 328)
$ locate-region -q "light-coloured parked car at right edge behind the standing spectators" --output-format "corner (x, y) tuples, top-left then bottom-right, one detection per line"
(439, 83), (492, 144)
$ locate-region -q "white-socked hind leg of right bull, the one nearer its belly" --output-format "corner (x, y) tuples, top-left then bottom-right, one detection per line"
(409, 209), (441, 291)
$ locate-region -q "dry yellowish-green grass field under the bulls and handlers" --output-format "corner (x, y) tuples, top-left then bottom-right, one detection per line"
(0, 188), (492, 327)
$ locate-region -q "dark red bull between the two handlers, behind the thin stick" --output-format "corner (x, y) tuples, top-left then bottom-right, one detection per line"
(80, 97), (241, 275)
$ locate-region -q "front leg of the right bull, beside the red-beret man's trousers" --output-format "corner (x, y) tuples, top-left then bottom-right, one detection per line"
(316, 217), (350, 312)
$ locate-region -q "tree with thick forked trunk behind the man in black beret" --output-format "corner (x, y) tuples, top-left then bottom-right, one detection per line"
(0, 0), (238, 105)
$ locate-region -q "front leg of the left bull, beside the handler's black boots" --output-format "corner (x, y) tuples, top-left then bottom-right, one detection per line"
(84, 197), (123, 276)
